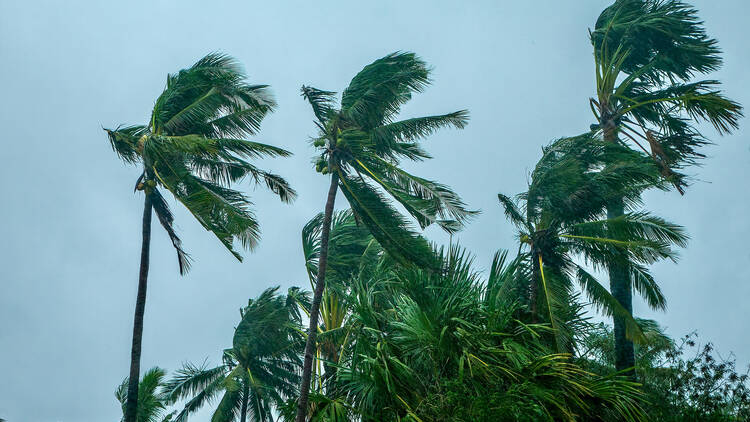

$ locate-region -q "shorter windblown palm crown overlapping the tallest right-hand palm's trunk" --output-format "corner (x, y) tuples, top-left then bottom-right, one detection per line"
(498, 134), (687, 352)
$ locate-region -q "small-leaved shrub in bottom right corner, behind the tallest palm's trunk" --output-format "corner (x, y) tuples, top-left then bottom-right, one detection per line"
(581, 321), (750, 422)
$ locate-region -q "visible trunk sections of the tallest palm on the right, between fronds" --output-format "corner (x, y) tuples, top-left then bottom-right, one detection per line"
(601, 118), (635, 379)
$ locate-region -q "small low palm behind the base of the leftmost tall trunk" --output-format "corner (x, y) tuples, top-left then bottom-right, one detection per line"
(115, 368), (174, 422)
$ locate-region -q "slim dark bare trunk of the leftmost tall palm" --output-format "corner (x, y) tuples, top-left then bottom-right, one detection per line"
(124, 193), (152, 422)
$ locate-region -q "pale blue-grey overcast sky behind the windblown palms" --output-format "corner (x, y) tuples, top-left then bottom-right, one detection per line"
(0, 0), (750, 422)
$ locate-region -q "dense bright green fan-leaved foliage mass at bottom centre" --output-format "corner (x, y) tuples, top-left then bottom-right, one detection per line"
(326, 248), (642, 421)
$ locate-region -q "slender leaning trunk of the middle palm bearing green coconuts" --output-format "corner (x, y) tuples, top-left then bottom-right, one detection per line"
(294, 171), (339, 422)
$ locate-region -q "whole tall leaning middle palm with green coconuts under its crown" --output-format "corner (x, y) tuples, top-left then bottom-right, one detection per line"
(296, 53), (472, 422)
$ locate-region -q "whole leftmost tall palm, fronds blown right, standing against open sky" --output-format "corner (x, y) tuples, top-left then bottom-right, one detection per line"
(105, 54), (296, 422)
